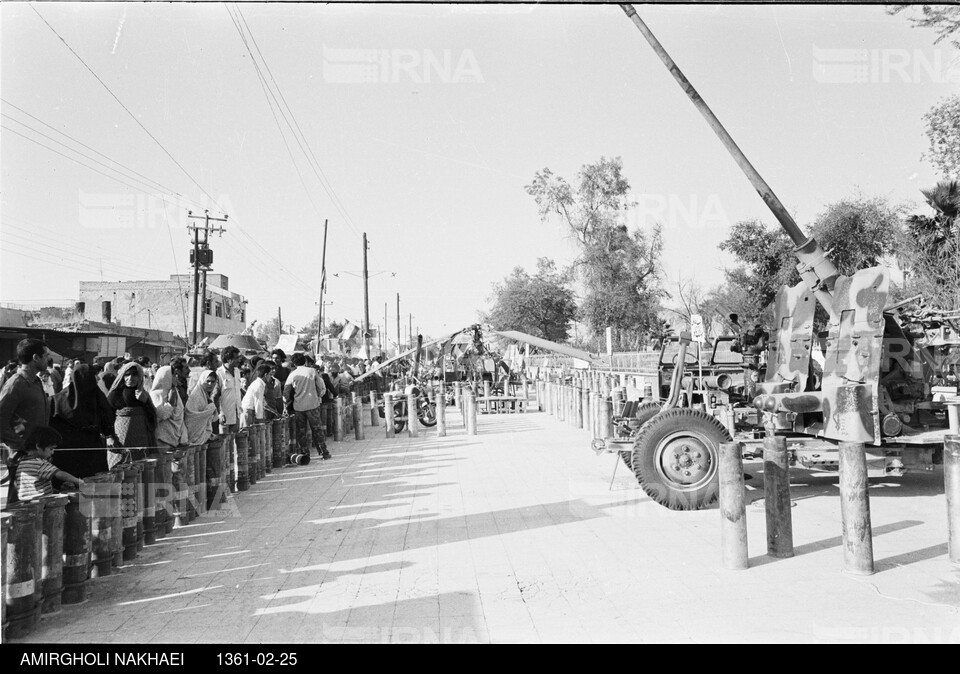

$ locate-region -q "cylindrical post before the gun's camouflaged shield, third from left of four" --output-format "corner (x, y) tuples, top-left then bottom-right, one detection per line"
(840, 442), (874, 576)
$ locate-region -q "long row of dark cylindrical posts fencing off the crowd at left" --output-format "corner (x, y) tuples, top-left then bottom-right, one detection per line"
(2, 417), (308, 639)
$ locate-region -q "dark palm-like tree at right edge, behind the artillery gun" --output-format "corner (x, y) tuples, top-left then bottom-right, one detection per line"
(901, 181), (960, 311)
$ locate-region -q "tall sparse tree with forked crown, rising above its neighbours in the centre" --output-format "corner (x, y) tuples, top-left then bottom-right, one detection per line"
(525, 157), (663, 348)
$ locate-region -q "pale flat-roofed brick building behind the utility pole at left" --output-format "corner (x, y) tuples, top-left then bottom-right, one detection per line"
(77, 274), (247, 340)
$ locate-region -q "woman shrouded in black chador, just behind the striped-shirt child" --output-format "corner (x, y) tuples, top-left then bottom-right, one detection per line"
(50, 363), (119, 478)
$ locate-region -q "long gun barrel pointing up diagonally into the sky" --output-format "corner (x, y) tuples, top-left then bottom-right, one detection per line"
(621, 4), (839, 315)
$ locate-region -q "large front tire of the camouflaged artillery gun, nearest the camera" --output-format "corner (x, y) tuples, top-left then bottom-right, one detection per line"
(632, 408), (731, 510)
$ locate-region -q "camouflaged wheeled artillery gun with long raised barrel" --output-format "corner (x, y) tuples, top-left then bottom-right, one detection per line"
(594, 5), (960, 510)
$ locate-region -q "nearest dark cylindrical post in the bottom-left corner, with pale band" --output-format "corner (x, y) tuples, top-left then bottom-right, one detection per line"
(3, 501), (43, 639)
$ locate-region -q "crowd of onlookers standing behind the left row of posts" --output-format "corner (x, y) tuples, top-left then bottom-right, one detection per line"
(0, 339), (382, 502)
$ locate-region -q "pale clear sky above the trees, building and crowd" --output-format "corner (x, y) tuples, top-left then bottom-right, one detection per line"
(0, 2), (960, 339)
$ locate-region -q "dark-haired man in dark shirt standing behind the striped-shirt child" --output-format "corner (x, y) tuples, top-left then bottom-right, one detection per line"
(0, 338), (51, 450)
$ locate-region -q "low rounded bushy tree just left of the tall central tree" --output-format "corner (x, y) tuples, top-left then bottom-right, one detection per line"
(484, 257), (577, 342)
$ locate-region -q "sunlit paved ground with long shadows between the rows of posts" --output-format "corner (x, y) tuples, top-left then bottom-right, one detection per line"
(9, 408), (960, 644)
